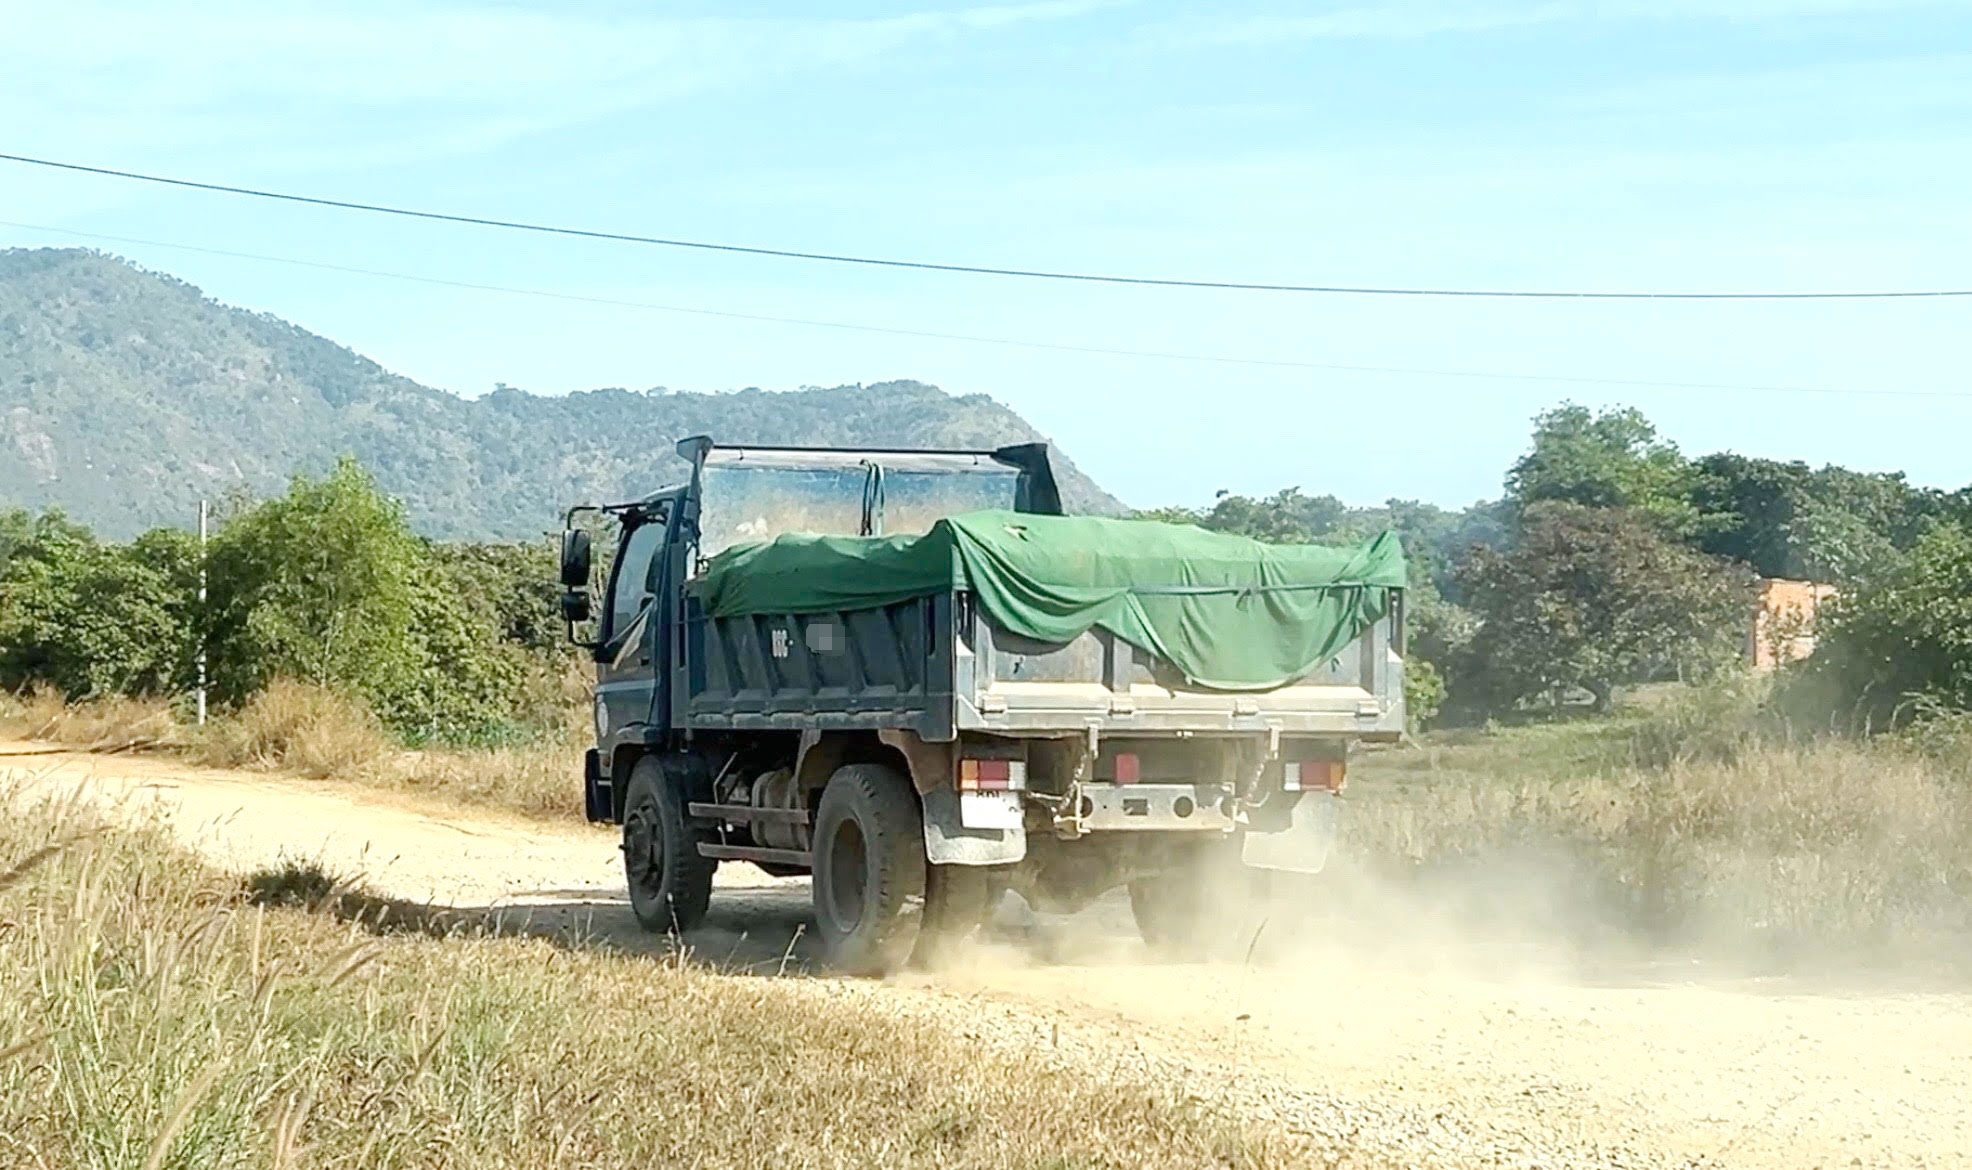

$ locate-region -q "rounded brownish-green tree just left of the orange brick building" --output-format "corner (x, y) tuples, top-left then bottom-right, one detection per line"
(1457, 501), (1751, 710)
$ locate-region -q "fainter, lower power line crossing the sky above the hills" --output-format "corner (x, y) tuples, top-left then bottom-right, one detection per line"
(15, 219), (1972, 401)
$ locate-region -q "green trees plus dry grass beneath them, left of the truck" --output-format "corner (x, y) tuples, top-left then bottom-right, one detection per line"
(0, 451), (588, 817)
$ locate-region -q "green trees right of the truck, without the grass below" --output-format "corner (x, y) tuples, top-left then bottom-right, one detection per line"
(1144, 404), (1972, 726)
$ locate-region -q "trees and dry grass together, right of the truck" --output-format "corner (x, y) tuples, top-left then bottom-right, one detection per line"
(1160, 406), (1972, 961)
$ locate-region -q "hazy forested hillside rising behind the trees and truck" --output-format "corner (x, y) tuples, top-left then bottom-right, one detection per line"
(0, 249), (1120, 539)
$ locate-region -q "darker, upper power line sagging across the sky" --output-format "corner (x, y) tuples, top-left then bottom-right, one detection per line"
(0, 154), (1972, 300)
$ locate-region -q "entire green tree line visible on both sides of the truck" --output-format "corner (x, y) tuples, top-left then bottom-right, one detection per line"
(0, 404), (1972, 740)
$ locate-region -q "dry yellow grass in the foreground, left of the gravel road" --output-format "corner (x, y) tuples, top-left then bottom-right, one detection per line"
(0, 777), (1309, 1170)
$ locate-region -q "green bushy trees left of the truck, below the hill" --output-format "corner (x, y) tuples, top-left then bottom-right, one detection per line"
(0, 460), (566, 742)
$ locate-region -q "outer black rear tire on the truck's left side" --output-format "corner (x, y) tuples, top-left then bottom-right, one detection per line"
(812, 764), (927, 975)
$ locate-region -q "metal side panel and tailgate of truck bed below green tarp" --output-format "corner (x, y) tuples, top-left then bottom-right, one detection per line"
(674, 592), (1404, 742)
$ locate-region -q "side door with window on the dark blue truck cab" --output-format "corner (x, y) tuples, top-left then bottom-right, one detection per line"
(596, 515), (670, 742)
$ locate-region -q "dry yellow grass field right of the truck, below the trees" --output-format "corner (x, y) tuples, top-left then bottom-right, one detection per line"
(1347, 695), (1972, 957)
